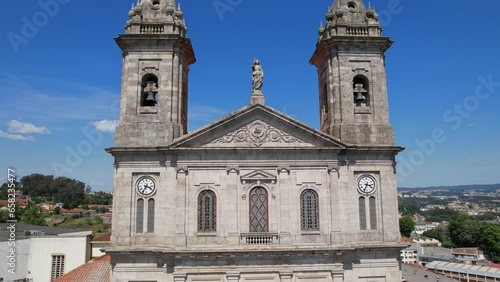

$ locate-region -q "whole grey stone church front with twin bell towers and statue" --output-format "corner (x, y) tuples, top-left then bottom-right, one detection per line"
(107, 0), (402, 282)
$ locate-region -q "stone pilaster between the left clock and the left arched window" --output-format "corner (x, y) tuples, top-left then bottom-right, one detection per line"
(175, 167), (188, 247)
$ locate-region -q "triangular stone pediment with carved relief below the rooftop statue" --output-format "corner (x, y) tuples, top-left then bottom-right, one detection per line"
(171, 104), (345, 149)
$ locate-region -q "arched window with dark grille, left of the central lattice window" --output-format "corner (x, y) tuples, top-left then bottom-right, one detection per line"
(198, 190), (217, 231)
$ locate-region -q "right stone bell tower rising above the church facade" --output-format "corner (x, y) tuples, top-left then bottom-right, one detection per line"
(310, 0), (394, 146)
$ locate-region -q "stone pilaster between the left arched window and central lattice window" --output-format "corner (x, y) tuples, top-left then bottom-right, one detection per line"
(228, 166), (240, 245)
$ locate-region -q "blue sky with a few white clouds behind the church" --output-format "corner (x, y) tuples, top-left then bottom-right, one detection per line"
(0, 0), (500, 191)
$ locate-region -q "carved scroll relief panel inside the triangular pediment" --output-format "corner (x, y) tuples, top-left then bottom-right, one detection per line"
(212, 120), (305, 147)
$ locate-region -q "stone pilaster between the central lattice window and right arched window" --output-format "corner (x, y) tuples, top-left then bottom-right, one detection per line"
(277, 165), (292, 244)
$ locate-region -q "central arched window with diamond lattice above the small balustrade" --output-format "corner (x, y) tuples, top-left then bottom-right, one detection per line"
(250, 187), (269, 232)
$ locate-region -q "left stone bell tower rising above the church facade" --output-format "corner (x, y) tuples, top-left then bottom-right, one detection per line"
(115, 0), (196, 147)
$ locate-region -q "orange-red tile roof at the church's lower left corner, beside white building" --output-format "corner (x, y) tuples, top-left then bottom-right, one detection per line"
(54, 255), (111, 282)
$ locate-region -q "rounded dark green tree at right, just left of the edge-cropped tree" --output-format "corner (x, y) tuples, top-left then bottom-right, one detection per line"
(448, 214), (481, 247)
